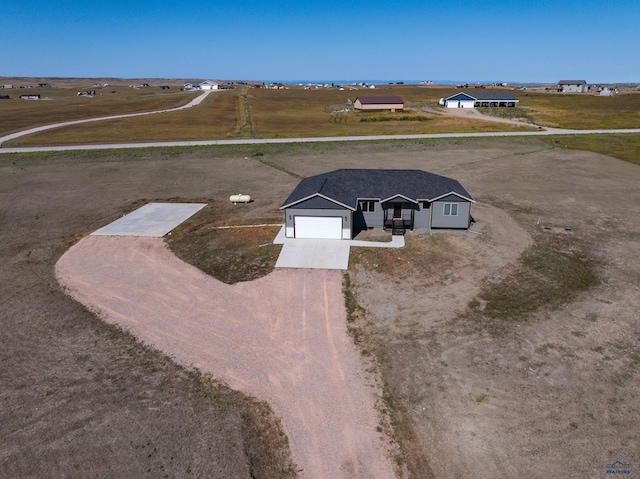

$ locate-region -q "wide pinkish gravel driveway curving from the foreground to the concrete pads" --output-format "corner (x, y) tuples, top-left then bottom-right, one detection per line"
(56, 236), (394, 478)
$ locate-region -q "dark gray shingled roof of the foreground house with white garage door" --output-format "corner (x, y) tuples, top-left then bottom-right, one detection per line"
(280, 169), (475, 210)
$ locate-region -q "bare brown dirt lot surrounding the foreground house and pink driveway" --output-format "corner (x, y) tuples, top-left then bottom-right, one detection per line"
(0, 139), (640, 478)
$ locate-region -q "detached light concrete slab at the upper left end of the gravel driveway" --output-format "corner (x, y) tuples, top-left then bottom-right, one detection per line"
(91, 203), (207, 238)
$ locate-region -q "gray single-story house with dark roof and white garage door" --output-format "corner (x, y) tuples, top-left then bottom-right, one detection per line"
(280, 169), (475, 240)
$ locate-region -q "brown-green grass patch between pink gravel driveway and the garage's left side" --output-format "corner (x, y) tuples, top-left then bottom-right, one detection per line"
(166, 201), (282, 284)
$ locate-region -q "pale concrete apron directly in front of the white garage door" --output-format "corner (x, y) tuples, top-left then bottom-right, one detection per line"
(276, 238), (350, 269)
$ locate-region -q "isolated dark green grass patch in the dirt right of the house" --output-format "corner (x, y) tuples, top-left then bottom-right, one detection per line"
(480, 246), (599, 320)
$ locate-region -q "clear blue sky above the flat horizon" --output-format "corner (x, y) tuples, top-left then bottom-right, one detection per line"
(0, 0), (640, 83)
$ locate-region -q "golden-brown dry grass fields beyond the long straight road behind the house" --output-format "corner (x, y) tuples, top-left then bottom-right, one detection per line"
(5, 80), (640, 146)
